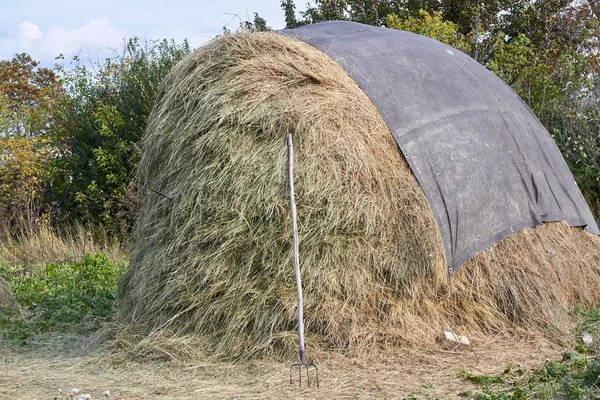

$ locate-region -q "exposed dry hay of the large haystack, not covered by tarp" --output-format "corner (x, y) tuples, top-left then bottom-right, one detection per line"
(119, 33), (600, 359)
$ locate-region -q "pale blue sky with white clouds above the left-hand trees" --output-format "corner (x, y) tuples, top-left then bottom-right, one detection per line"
(0, 0), (296, 66)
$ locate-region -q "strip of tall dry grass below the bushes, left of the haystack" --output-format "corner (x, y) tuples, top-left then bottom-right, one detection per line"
(0, 225), (126, 264)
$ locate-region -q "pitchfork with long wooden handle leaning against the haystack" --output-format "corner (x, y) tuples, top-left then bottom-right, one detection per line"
(288, 133), (319, 387)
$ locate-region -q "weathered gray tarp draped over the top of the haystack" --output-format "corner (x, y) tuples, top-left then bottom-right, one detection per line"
(281, 21), (600, 273)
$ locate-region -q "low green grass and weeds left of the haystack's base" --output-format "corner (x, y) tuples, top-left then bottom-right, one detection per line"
(0, 253), (126, 345)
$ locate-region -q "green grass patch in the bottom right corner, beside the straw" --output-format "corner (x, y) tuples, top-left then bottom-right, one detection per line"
(458, 305), (600, 400)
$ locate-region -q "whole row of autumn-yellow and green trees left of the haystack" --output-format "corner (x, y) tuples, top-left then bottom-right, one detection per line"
(0, 38), (190, 237)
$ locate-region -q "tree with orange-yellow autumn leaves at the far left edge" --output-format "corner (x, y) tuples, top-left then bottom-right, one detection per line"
(0, 53), (63, 229)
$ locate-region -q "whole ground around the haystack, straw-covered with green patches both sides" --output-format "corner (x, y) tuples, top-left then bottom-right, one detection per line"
(0, 253), (600, 400)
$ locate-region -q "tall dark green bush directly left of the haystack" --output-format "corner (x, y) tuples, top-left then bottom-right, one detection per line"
(52, 38), (191, 236)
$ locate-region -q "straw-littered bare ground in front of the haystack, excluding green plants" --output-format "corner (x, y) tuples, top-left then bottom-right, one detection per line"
(0, 339), (561, 400)
